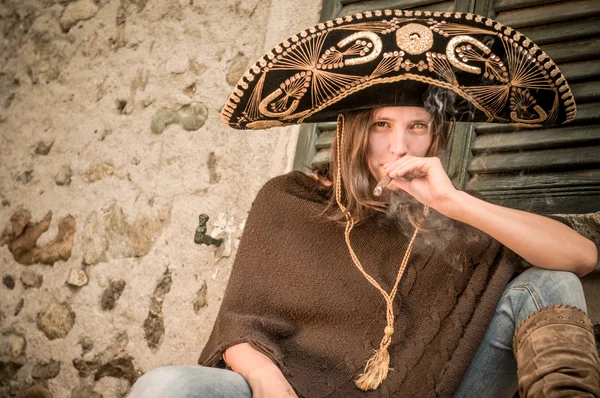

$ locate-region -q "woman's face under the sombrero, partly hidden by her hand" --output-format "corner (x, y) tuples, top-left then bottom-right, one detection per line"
(367, 106), (433, 181)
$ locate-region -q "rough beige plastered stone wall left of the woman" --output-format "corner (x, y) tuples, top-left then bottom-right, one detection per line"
(0, 0), (321, 398)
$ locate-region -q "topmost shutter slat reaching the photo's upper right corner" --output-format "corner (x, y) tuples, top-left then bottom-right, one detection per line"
(495, 0), (600, 29)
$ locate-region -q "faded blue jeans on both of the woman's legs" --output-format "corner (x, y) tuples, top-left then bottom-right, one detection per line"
(128, 268), (586, 398)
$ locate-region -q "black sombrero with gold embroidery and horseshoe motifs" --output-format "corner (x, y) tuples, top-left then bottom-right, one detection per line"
(221, 10), (576, 129)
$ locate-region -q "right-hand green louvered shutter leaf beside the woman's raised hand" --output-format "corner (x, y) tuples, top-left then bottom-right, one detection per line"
(462, 0), (600, 213)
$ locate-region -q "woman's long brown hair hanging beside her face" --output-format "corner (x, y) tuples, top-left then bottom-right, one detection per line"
(313, 90), (453, 224)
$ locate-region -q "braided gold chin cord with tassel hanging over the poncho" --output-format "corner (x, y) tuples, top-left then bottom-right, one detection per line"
(335, 114), (429, 391)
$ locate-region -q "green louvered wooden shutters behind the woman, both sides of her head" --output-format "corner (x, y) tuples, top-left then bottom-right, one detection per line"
(294, 0), (600, 213)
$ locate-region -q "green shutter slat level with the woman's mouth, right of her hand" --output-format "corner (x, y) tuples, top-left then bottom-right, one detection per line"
(467, 146), (600, 174)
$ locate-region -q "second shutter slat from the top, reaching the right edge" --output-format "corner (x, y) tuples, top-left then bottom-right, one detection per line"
(519, 18), (600, 45)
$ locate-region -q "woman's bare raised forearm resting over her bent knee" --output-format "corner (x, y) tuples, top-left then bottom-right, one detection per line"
(445, 191), (598, 276)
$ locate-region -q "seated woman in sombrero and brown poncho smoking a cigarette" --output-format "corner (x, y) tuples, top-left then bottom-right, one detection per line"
(130, 10), (600, 397)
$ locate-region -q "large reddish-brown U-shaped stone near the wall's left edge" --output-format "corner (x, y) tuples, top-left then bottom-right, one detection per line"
(8, 212), (75, 265)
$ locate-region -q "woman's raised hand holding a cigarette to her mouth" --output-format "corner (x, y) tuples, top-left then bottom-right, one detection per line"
(383, 155), (459, 215)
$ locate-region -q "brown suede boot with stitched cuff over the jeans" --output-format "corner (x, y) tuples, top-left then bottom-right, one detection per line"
(513, 305), (600, 398)
